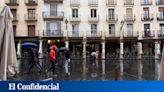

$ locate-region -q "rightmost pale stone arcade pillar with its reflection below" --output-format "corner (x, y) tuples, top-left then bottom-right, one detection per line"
(155, 41), (160, 79)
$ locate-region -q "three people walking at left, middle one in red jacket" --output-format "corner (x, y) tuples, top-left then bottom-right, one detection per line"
(25, 45), (70, 77)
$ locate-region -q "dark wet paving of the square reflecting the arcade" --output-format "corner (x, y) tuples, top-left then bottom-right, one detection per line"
(9, 54), (155, 80)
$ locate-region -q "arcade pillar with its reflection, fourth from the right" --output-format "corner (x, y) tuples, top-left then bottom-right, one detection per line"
(101, 41), (105, 75)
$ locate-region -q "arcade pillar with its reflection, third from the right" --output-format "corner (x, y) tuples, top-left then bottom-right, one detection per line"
(120, 41), (124, 80)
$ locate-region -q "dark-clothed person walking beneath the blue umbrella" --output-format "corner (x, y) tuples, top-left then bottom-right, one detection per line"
(28, 48), (42, 74)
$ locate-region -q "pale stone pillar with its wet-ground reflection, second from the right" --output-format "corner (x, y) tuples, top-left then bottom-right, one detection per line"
(138, 41), (143, 80)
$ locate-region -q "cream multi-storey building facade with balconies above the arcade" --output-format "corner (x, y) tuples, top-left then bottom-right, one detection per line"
(5, 0), (164, 79)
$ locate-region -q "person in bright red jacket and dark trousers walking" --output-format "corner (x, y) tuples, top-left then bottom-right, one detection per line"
(47, 45), (57, 77)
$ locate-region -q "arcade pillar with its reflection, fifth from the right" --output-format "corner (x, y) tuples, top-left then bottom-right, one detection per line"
(83, 41), (86, 80)
